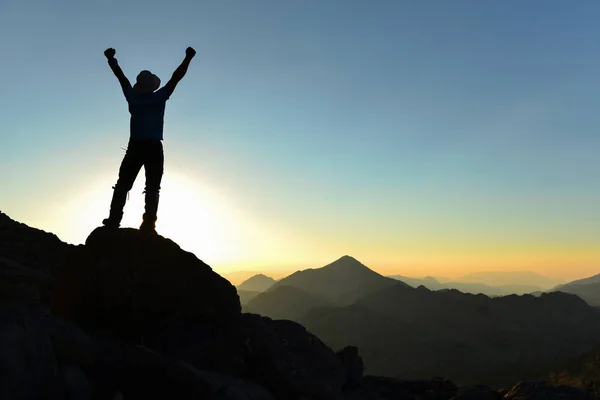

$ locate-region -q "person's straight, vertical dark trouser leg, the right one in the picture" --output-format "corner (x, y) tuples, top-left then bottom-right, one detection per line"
(144, 140), (164, 224)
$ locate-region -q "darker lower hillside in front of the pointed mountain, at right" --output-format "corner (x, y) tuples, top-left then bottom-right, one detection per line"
(299, 286), (600, 385)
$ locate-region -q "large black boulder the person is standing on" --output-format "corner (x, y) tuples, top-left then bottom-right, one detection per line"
(51, 227), (241, 370)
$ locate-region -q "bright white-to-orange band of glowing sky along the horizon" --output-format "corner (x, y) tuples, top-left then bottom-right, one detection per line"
(3, 169), (600, 280)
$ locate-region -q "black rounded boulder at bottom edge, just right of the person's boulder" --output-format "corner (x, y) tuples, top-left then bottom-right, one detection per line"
(242, 314), (346, 399)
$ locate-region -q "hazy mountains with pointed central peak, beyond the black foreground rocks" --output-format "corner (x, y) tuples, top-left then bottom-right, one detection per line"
(245, 256), (600, 385)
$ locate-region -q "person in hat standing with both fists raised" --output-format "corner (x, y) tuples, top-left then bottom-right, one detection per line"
(102, 47), (196, 233)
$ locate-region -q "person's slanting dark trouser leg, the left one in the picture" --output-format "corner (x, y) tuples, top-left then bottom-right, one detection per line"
(109, 142), (144, 222)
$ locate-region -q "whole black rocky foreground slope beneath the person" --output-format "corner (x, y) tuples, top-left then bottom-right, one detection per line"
(0, 214), (592, 400)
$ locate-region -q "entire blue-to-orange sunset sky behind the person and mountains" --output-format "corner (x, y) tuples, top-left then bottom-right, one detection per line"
(0, 0), (600, 279)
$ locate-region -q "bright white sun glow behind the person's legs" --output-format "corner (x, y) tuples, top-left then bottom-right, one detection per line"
(58, 169), (252, 264)
